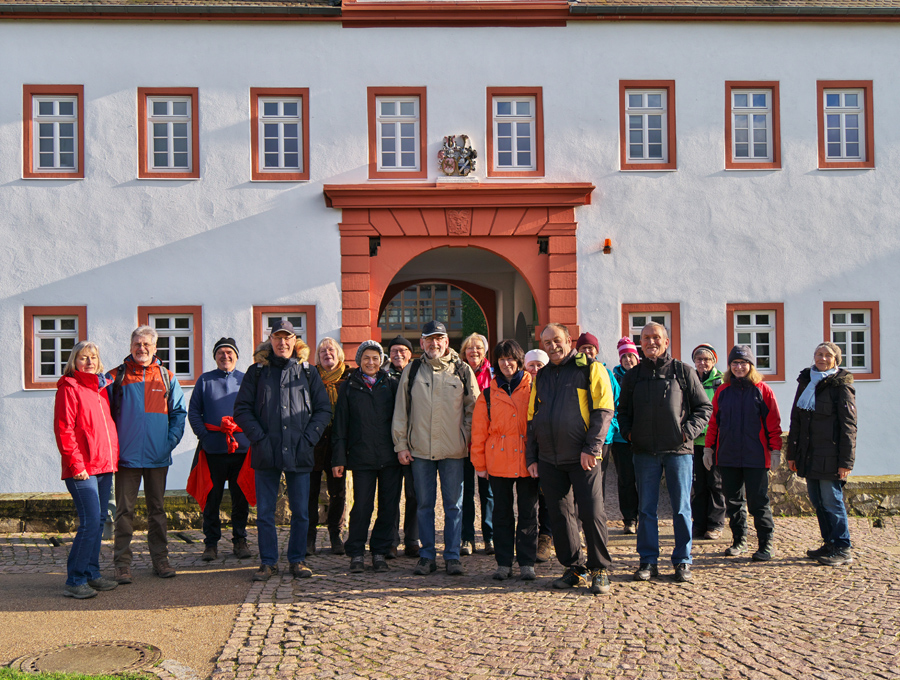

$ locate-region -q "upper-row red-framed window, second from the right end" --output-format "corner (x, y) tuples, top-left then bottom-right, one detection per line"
(725, 81), (781, 170)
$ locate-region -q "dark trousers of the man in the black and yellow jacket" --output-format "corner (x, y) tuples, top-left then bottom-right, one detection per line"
(538, 461), (612, 570)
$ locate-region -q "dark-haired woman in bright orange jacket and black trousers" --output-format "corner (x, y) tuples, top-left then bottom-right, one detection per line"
(471, 340), (538, 581)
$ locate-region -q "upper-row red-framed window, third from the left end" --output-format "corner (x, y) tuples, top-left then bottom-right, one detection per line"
(250, 87), (309, 182)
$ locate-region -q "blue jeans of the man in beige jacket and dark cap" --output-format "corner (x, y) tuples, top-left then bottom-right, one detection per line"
(412, 458), (466, 561)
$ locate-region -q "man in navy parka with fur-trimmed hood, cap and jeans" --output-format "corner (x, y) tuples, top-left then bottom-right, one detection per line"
(234, 321), (331, 581)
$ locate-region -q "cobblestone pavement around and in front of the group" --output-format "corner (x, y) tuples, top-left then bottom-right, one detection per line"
(0, 494), (900, 680)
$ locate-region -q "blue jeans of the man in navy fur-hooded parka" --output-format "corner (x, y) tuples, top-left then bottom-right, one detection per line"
(255, 468), (309, 566)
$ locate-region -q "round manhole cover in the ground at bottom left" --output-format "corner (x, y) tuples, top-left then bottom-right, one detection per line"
(10, 640), (162, 675)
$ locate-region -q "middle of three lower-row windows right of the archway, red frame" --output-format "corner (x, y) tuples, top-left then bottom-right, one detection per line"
(725, 302), (784, 381)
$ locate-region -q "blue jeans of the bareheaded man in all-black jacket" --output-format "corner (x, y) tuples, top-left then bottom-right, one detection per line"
(634, 453), (694, 565)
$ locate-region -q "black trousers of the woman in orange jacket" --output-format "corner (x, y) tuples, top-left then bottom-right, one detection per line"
(489, 477), (539, 567)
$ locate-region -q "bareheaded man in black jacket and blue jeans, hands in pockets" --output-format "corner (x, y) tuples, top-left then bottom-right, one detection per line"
(618, 323), (712, 583)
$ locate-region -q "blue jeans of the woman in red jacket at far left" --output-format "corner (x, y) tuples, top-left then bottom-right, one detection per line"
(65, 472), (113, 586)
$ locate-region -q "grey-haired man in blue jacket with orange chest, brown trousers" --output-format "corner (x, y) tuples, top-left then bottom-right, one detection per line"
(107, 326), (187, 584)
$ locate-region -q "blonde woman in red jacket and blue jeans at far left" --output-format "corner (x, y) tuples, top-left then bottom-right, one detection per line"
(53, 341), (119, 600)
